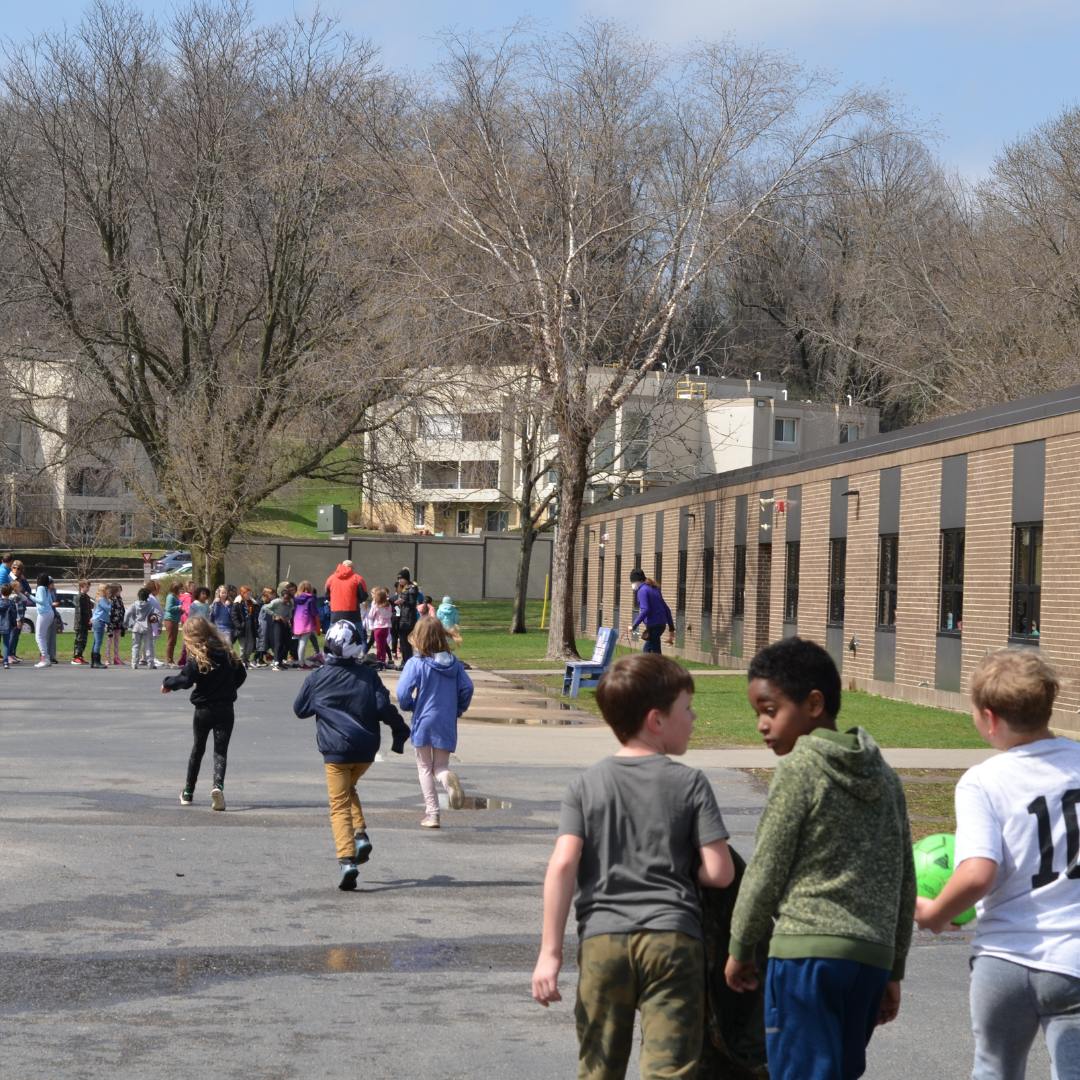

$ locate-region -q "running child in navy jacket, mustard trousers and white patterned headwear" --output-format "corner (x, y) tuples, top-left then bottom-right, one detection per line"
(293, 619), (408, 890)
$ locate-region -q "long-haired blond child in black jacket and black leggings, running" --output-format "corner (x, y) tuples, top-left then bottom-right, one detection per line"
(161, 616), (247, 810)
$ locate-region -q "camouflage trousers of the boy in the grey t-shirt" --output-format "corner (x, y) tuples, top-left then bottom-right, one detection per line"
(575, 931), (705, 1080)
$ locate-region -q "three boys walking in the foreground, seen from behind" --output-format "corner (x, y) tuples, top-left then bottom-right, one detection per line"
(532, 638), (1080, 1080)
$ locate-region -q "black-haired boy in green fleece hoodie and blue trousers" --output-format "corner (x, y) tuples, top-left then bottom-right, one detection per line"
(725, 637), (916, 1080)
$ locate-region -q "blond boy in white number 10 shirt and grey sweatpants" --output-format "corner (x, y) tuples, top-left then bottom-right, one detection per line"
(915, 649), (1080, 1080)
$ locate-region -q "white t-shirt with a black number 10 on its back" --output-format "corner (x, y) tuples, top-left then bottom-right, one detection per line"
(956, 739), (1080, 977)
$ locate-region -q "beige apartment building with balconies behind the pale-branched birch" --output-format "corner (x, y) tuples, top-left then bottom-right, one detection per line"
(365, 370), (878, 536)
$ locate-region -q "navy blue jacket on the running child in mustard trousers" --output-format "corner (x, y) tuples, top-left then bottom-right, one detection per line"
(293, 656), (409, 765)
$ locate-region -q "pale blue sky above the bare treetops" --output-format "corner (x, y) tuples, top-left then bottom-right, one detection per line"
(0, 0), (1080, 177)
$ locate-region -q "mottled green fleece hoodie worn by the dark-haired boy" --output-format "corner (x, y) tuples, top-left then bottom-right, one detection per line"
(730, 728), (916, 978)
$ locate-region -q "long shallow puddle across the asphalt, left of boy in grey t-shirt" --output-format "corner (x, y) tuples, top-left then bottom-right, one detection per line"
(0, 939), (552, 1013)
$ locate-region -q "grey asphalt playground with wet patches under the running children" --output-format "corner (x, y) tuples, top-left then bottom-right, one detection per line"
(0, 663), (1050, 1080)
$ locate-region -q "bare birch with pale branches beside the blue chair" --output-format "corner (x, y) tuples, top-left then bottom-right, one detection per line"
(371, 23), (902, 659)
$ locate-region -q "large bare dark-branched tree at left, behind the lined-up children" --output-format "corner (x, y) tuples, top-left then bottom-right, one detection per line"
(0, 0), (414, 584)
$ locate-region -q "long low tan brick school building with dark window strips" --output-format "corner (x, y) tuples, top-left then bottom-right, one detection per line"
(575, 387), (1080, 733)
